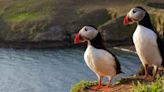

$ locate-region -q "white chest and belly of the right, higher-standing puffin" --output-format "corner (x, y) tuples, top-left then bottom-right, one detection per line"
(133, 25), (162, 65)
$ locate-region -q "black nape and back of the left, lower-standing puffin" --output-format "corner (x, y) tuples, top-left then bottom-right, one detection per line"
(91, 33), (122, 74)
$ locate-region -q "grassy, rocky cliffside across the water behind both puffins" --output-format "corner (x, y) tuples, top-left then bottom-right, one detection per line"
(0, 0), (164, 48)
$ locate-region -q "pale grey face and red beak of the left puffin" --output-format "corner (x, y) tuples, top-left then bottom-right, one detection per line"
(74, 26), (98, 44)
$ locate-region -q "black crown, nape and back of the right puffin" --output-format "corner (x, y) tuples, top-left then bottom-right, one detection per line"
(136, 6), (164, 66)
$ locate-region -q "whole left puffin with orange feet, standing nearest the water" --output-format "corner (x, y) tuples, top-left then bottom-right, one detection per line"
(74, 25), (121, 89)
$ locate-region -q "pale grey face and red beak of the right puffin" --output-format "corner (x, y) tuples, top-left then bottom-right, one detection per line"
(124, 7), (146, 25)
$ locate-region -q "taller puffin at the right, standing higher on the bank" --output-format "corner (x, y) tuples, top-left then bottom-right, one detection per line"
(123, 6), (164, 81)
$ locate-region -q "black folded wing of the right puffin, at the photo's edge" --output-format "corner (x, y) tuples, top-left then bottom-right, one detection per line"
(157, 36), (164, 67)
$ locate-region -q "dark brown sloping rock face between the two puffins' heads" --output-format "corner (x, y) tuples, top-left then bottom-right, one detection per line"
(98, 16), (136, 46)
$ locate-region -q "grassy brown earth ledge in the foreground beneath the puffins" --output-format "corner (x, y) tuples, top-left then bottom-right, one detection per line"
(70, 74), (164, 92)
